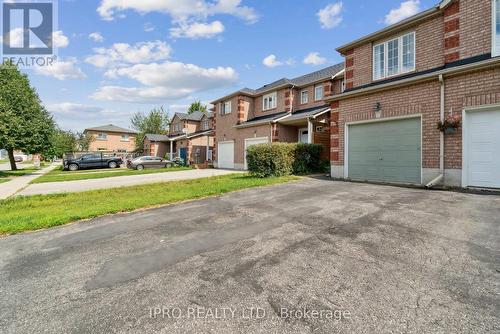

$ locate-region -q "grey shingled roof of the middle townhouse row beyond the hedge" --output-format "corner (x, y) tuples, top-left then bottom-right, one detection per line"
(212, 63), (344, 104)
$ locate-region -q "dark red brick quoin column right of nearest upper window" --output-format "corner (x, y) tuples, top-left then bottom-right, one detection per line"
(444, 1), (460, 63)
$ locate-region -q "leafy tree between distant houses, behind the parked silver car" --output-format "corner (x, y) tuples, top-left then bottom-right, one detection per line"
(130, 107), (170, 151)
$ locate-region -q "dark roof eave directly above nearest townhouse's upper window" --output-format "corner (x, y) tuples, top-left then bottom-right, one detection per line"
(336, 0), (453, 54)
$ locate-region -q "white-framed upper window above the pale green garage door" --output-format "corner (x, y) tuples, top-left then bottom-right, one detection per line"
(373, 32), (415, 80)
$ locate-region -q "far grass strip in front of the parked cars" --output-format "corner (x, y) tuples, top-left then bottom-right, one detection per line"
(31, 167), (191, 183)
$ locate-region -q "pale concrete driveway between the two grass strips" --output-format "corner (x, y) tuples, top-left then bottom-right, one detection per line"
(17, 169), (242, 196)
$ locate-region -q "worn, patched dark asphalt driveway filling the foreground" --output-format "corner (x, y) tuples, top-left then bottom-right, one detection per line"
(0, 179), (500, 334)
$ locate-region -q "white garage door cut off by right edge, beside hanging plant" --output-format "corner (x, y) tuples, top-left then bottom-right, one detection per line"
(464, 110), (500, 188)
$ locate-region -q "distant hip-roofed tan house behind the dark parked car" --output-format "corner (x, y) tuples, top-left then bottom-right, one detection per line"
(83, 124), (137, 153)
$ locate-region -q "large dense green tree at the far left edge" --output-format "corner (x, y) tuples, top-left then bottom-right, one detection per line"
(0, 62), (55, 170)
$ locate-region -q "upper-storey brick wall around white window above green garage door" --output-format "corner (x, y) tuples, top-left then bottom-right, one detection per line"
(345, 0), (492, 88)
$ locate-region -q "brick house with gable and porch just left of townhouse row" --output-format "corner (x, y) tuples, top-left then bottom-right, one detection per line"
(144, 111), (214, 165)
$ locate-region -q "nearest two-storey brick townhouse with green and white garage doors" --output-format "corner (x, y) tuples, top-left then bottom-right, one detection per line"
(328, 0), (500, 188)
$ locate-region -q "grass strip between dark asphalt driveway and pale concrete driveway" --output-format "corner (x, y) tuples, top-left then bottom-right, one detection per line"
(0, 174), (299, 234)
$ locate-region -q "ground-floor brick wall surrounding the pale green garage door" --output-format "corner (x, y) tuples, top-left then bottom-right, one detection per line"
(331, 68), (500, 169)
